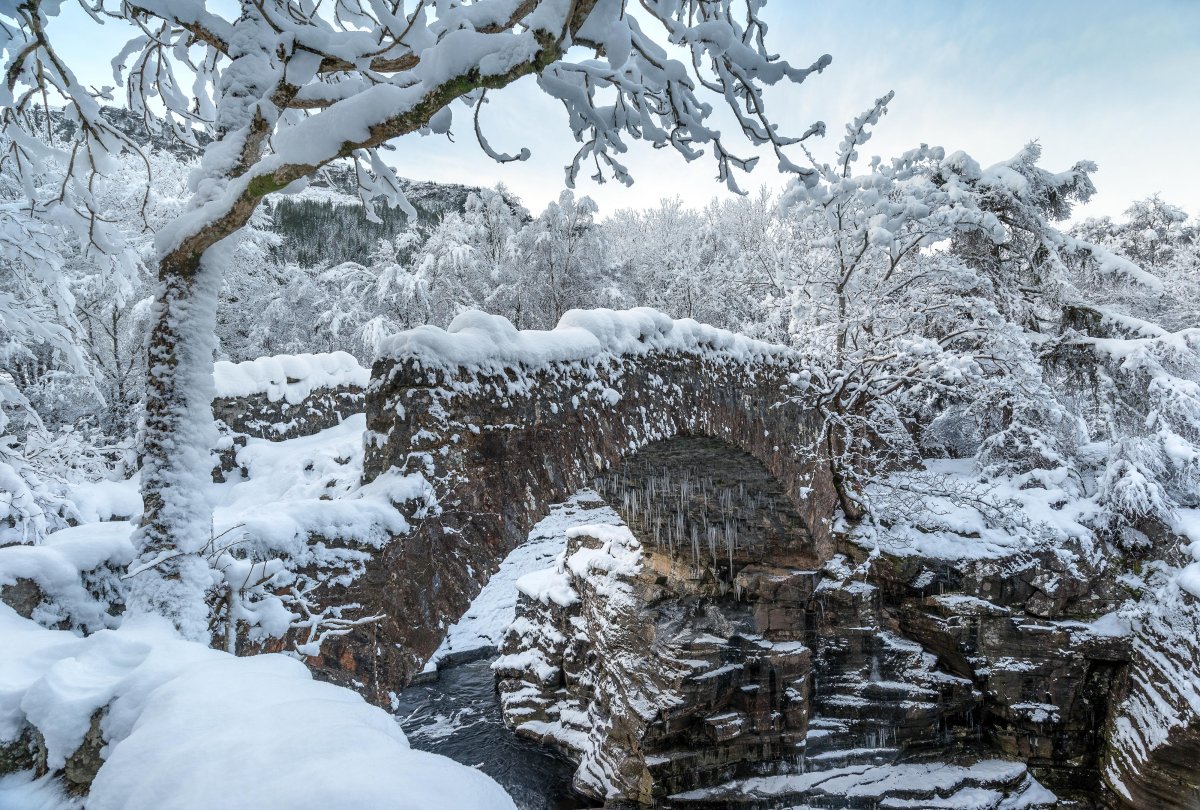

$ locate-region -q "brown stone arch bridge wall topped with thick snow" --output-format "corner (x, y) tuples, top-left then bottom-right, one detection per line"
(317, 310), (835, 689)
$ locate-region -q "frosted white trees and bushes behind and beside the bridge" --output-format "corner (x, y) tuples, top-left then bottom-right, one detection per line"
(0, 108), (1200, 571)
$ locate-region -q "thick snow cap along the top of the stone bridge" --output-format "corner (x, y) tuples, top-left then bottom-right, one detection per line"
(379, 307), (790, 371)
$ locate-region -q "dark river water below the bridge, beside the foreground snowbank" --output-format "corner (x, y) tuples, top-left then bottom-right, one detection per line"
(396, 660), (596, 810)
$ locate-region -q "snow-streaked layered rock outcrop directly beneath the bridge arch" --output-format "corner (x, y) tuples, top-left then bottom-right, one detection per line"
(493, 527), (811, 804)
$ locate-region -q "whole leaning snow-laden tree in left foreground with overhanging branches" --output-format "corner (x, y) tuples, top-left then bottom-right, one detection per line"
(0, 0), (830, 638)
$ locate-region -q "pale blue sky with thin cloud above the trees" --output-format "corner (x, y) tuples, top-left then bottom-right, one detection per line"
(51, 0), (1200, 218)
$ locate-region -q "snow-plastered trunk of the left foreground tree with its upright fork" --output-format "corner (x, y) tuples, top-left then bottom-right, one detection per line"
(128, 31), (289, 640)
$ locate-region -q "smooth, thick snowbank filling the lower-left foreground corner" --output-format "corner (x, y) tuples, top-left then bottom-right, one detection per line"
(0, 606), (514, 810)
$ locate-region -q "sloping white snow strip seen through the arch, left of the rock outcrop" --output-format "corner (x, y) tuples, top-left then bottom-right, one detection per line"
(425, 490), (622, 673)
